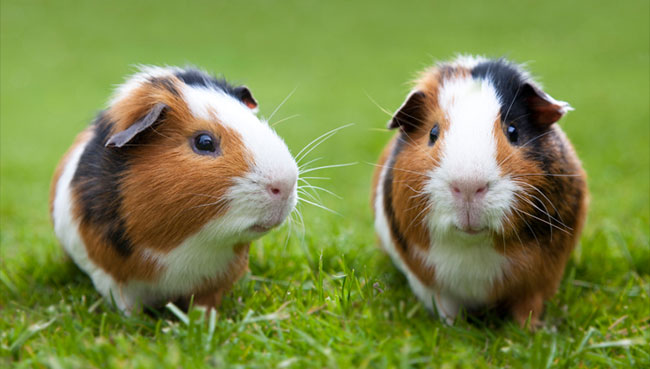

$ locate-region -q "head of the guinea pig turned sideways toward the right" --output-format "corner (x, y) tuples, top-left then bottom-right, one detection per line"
(98, 67), (298, 247)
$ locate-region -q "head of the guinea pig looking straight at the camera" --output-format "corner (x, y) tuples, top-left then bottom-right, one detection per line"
(389, 57), (571, 240)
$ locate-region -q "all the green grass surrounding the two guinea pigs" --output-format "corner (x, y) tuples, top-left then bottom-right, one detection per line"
(0, 0), (650, 368)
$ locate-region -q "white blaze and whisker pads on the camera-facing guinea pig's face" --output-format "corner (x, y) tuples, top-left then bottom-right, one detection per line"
(425, 77), (517, 234)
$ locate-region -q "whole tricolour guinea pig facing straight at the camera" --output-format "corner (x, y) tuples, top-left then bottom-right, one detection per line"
(372, 56), (588, 328)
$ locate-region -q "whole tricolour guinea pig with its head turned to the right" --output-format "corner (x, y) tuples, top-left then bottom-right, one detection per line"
(50, 67), (298, 314)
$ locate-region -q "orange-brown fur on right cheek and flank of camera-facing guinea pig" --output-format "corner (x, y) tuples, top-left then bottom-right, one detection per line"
(491, 120), (588, 325)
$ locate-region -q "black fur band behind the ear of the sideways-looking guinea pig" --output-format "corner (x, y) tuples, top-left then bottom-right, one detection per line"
(72, 112), (133, 257)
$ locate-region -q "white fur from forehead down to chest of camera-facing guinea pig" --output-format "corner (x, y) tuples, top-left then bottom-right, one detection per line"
(423, 77), (516, 306)
